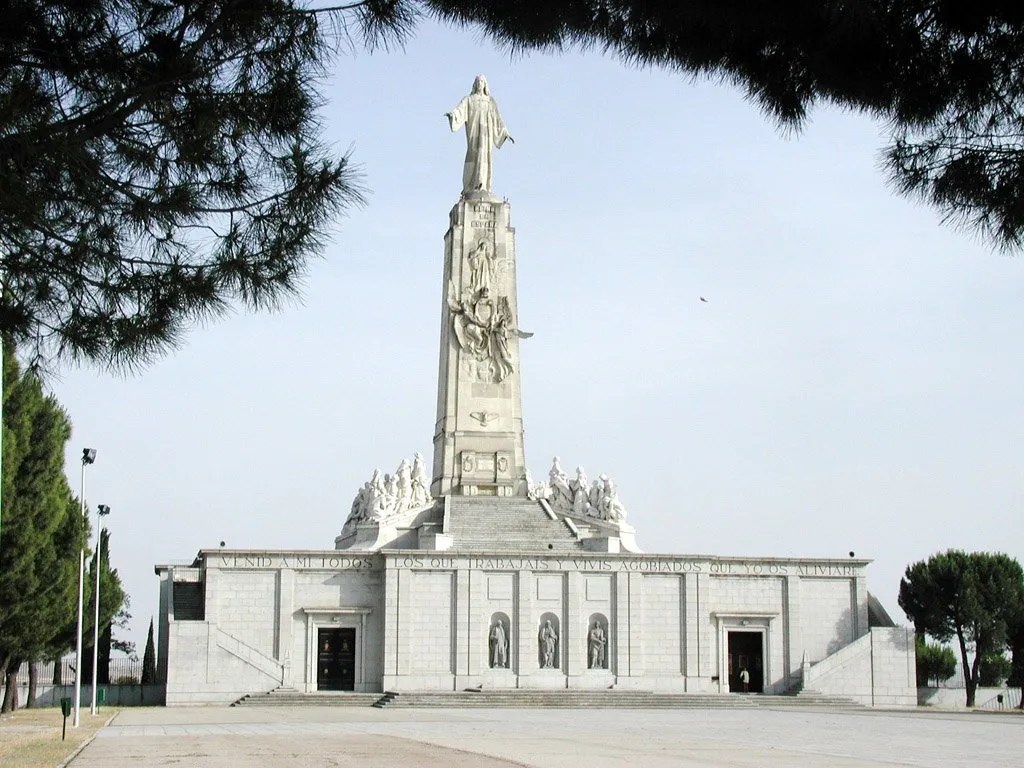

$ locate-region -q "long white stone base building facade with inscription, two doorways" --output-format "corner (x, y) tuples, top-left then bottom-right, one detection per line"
(151, 550), (916, 706)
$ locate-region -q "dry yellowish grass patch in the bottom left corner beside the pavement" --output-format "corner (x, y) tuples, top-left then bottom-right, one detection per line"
(0, 707), (117, 768)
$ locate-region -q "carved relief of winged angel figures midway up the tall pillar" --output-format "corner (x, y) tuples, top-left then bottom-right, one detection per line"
(447, 282), (522, 382)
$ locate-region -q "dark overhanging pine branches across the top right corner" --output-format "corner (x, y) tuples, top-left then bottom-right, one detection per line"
(423, 0), (1024, 248)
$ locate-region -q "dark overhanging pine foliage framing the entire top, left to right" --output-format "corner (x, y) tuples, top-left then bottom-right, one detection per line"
(6, 0), (1024, 367)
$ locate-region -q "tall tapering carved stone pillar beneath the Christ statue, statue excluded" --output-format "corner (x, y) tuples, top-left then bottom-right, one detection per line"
(430, 196), (527, 498)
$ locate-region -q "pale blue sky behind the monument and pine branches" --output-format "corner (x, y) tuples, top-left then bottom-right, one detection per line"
(52, 24), (1024, 649)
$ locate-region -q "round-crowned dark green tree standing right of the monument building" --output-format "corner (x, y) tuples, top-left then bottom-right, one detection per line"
(899, 550), (1024, 707)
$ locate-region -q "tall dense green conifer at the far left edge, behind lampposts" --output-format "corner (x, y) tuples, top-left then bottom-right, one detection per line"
(0, 354), (86, 711)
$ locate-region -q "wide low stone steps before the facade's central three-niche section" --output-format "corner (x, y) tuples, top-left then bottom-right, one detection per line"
(374, 689), (757, 710)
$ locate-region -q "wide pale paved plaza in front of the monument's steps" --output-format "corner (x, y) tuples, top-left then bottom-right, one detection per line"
(70, 707), (1024, 768)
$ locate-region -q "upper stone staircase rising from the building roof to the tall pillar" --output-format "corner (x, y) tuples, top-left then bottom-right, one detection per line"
(447, 496), (583, 553)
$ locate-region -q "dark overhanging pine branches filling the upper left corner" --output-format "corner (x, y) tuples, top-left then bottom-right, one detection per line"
(0, 0), (401, 366)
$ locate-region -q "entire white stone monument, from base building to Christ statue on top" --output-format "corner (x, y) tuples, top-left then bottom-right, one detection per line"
(149, 76), (916, 706)
